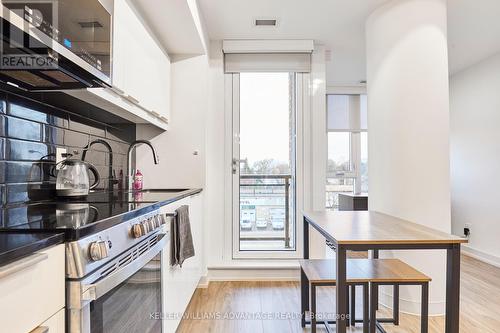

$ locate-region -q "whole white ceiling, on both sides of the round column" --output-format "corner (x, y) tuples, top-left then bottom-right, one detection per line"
(193, 0), (500, 85)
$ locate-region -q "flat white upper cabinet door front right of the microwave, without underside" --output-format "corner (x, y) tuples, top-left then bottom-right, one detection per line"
(112, 0), (170, 120)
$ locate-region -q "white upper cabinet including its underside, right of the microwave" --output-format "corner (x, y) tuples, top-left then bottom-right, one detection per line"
(65, 0), (170, 130)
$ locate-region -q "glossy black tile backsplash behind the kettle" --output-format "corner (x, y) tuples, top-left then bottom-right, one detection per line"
(0, 90), (135, 206)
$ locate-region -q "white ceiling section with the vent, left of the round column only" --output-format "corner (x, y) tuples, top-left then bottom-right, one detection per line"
(198, 0), (386, 85)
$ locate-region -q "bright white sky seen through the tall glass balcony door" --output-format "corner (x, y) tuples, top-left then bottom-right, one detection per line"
(240, 73), (290, 165)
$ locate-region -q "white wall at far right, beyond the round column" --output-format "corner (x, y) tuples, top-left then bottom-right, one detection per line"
(450, 53), (500, 265)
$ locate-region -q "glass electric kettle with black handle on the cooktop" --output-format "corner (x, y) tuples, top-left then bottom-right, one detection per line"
(56, 159), (101, 197)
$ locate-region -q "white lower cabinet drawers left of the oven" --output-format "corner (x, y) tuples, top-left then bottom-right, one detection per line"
(0, 244), (65, 333)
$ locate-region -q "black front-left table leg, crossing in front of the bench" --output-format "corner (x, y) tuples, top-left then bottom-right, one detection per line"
(336, 245), (349, 333)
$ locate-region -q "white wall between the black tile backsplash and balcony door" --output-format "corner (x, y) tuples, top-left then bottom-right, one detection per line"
(137, 56), (208, 188)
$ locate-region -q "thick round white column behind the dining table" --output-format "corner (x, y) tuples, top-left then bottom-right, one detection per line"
(366, 0), (451, 314)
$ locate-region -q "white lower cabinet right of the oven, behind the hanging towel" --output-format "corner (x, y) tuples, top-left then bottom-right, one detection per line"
(162, 193), (205, 333)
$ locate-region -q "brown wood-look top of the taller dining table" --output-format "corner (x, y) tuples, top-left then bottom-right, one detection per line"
(303, 211), (468, 245)
